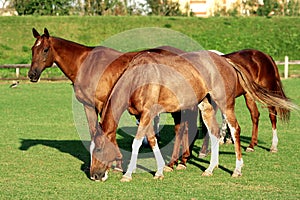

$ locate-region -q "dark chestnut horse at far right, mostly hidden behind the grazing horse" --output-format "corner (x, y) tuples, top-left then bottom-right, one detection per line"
(199, 49), (290, 157)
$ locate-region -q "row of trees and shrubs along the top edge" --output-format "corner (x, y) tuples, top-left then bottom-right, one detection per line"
(3, 0), (300, 16)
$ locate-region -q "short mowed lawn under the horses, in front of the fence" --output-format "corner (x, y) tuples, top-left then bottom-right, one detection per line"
(0, 79), (300, 199)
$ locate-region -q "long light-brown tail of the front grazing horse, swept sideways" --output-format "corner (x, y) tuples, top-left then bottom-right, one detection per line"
(226, 58), (299, 120)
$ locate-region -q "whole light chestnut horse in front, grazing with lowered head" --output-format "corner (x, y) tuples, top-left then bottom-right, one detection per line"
(90, 51), (294, 182)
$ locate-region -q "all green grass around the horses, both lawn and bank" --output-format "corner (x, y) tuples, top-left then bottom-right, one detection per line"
(0, 16), (300, 199)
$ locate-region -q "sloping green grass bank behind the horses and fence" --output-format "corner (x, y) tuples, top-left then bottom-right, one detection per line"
(0, 16), (300, 78)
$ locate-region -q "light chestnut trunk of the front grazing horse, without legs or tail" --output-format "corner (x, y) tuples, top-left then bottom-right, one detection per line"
(105, 51), (237, 115)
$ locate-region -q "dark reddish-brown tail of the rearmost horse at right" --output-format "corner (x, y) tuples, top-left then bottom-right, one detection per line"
(266, 55), (290, 122)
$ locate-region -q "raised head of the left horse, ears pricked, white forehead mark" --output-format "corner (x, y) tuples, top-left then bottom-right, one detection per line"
(28, 28), (54, 82)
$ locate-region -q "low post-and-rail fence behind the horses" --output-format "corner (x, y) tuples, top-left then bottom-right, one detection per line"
(0, 56), (300, 81)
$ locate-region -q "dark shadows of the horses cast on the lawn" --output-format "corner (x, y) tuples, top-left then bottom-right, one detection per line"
(19, 125), (253, 178)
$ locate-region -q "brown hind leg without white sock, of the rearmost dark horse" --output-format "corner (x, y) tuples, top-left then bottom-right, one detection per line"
(244, 94), (260, 152)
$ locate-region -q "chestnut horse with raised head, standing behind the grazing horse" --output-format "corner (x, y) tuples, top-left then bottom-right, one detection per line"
(28, 28), (197, 175)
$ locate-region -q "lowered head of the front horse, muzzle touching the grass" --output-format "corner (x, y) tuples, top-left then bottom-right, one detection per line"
(90, 129), (117, 181)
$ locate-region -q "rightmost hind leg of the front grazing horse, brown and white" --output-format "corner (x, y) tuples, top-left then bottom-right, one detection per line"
(224, 109), (244, 177)
